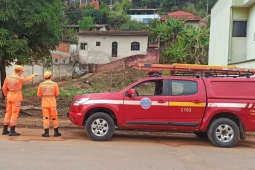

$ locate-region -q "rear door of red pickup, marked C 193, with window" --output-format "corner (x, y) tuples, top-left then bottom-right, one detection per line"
(169, 79), (206, 127)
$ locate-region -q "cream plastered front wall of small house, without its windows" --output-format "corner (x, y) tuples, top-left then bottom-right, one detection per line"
(79, 35), (148, 64)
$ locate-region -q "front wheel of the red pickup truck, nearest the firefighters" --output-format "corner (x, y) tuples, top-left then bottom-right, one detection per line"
(85, 112), (115, 141)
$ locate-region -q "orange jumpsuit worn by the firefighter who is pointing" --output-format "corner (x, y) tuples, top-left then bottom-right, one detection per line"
(2, 73), (35, 126)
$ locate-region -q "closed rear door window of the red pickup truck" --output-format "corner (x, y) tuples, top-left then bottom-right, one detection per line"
(172, 80), (198, 96)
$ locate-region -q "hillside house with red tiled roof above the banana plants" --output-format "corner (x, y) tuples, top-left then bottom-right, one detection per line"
(161, 10), (202, 27)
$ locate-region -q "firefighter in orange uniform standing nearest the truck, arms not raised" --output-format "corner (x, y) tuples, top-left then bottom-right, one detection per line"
(37, 71), (61, 137)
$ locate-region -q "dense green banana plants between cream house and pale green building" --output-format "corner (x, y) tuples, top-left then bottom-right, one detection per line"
(150, 18), (210, 64)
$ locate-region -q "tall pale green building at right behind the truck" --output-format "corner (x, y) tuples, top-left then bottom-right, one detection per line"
(209, 0), (255, 68)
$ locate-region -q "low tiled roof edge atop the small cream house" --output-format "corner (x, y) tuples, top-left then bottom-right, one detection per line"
(78, 30), (149, 36)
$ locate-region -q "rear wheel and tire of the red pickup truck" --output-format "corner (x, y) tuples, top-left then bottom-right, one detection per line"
(207, 118), (240, 148)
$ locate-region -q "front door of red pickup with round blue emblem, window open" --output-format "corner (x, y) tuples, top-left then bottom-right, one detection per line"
(124, 79), (169, 126)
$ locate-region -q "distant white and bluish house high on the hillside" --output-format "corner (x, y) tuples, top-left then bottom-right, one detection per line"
(127, 9), (160, 24)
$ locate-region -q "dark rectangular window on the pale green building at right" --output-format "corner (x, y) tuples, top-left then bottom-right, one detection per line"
(232, 21), (247, 37)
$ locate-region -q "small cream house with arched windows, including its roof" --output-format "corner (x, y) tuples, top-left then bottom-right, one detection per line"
(78, 31), (149, 64)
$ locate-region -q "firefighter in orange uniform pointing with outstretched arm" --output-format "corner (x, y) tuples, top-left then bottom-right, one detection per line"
(2, 65), (37, 136)
